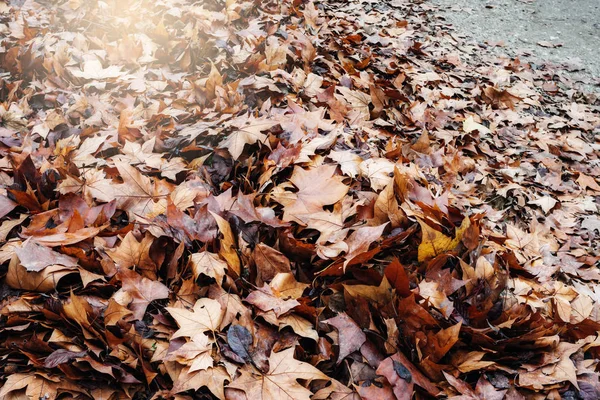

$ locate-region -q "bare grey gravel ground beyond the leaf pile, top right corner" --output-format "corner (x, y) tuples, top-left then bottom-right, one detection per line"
(431, 0), (600, 92)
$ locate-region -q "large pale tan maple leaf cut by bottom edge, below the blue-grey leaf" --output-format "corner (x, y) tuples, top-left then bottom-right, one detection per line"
(227, 347), (329, 400)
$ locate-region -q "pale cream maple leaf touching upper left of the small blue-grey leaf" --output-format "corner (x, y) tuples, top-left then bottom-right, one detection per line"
(166, 298), (223, 338)
